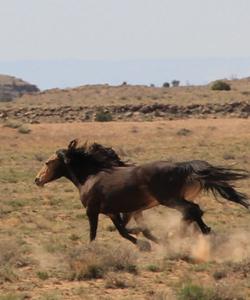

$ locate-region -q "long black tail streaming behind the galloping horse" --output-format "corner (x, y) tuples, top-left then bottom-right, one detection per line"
(186, 161), (250, 208)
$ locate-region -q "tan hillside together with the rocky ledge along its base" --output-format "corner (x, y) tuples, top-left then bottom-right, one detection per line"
(0, 78), (250, 123)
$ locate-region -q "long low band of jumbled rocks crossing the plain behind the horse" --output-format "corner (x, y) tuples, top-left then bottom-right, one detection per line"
(0, 101), (250, 124)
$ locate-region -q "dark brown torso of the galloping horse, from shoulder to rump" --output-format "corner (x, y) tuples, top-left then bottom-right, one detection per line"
(82, 161), (203, 214)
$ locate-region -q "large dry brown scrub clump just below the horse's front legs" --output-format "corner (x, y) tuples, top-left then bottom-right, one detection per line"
(66, 243), (137, 280)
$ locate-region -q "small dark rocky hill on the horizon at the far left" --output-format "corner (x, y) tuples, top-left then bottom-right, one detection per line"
(0, 74), (40, 102)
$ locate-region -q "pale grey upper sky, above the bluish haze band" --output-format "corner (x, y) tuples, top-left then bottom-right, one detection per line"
(0, 0), (250, 62)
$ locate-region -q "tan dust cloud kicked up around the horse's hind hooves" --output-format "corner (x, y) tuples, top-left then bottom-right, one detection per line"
(140, 211), (250, 262)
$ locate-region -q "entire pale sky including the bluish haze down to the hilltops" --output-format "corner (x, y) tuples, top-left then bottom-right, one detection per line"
(0, 0), (250, 89)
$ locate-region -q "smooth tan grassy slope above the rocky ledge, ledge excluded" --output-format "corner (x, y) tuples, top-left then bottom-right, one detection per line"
(2, 78), (250, 108)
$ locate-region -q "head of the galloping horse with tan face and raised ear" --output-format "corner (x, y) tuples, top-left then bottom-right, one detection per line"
(35, 140), (77, 186)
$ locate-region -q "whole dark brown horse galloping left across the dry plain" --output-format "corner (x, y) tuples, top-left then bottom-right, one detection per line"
(35, 140), (250, 250)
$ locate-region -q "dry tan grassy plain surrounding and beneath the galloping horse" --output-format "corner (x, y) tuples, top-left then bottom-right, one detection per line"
(0, 119), (250, 300)
